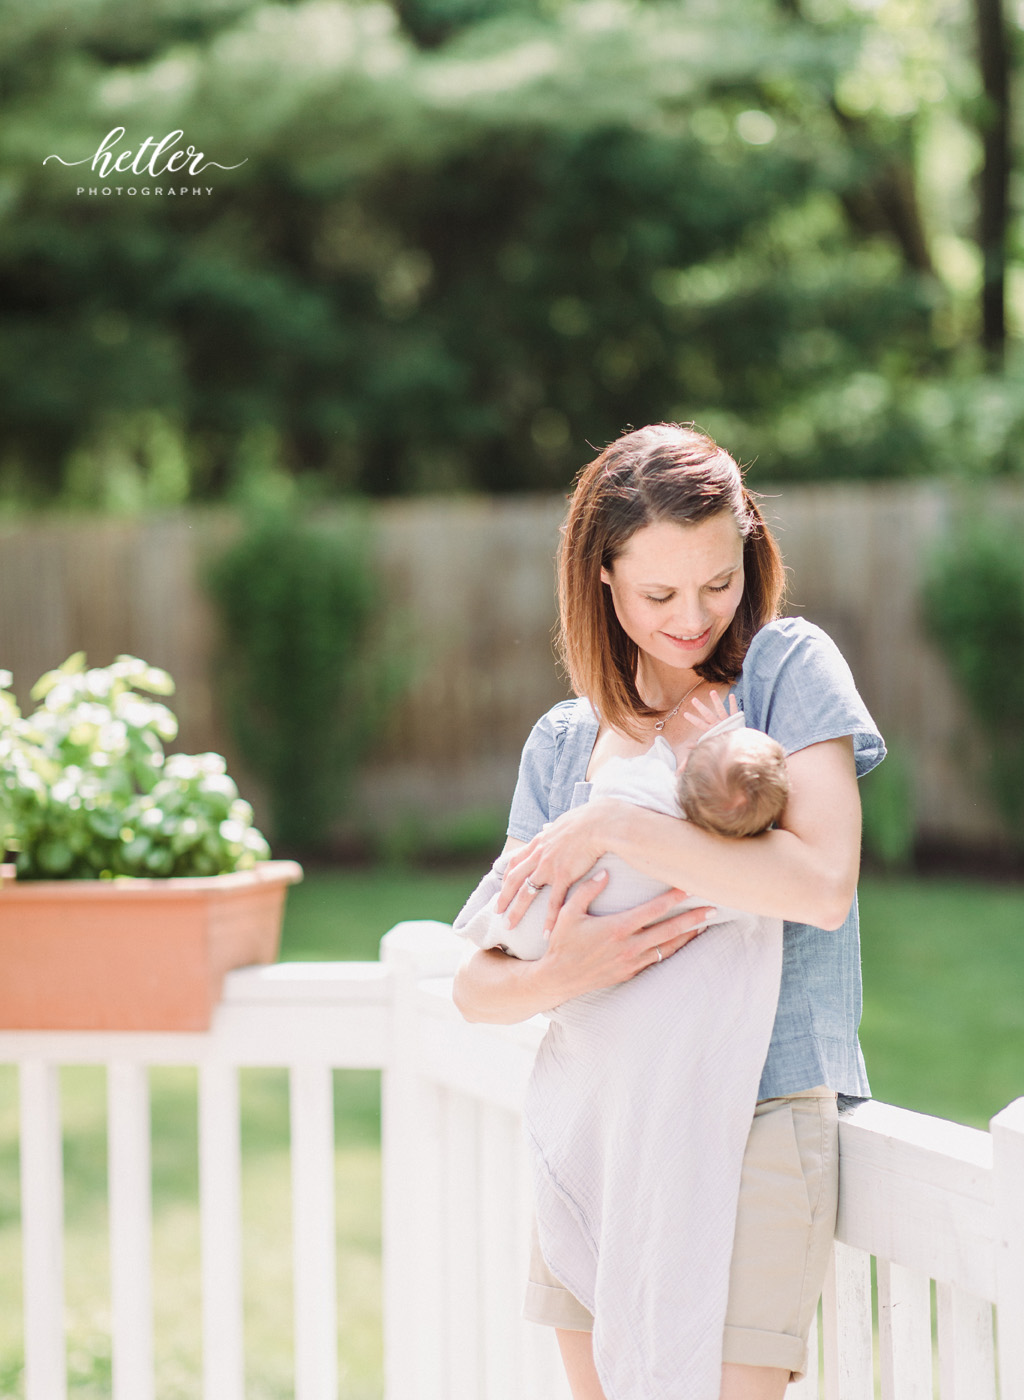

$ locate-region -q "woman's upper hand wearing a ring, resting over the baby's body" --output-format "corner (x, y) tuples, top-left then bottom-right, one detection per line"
(497, 798), (626, 932)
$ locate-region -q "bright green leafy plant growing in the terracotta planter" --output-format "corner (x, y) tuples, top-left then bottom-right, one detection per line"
(0, 652), (270, 879)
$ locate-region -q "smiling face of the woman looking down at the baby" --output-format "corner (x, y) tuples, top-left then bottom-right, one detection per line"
(601, 511), (742, 680)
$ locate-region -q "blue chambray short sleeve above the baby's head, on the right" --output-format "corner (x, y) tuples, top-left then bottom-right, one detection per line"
(735, 617), (885, 777)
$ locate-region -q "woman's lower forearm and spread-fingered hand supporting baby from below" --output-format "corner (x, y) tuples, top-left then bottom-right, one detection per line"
(454, 834), (712, 1023)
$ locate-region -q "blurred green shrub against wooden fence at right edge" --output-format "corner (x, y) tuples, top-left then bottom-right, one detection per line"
(923, 518), (1024, 848)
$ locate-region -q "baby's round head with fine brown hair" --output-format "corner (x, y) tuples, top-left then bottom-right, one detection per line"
(677, 729), (789, 836)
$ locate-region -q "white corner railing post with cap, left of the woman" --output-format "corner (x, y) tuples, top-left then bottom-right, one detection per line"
(381, 920), (464, 1400)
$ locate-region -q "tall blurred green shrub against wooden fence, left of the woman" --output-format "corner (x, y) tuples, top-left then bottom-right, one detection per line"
(207, 500), (399, 851)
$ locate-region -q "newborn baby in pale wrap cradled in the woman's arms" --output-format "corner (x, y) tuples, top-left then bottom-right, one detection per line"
(454, 697), (789, 960)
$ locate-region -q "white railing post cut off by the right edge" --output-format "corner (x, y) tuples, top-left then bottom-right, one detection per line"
(990, 1099), (1024, 1400)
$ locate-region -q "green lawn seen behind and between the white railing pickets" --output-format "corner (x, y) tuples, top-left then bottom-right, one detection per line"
(0, 868), (1024, 1400)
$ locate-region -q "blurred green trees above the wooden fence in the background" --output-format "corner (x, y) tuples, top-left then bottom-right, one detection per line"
(0, 0), (1024, 510)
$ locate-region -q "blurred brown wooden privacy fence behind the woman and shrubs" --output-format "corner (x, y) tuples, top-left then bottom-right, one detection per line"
(0, 482), (1024, 843)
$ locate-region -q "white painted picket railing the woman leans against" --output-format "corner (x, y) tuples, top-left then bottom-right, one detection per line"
(0, 923), (1024, 1400)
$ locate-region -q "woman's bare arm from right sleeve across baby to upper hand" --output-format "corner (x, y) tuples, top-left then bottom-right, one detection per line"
(499, 738), (860, 928)
